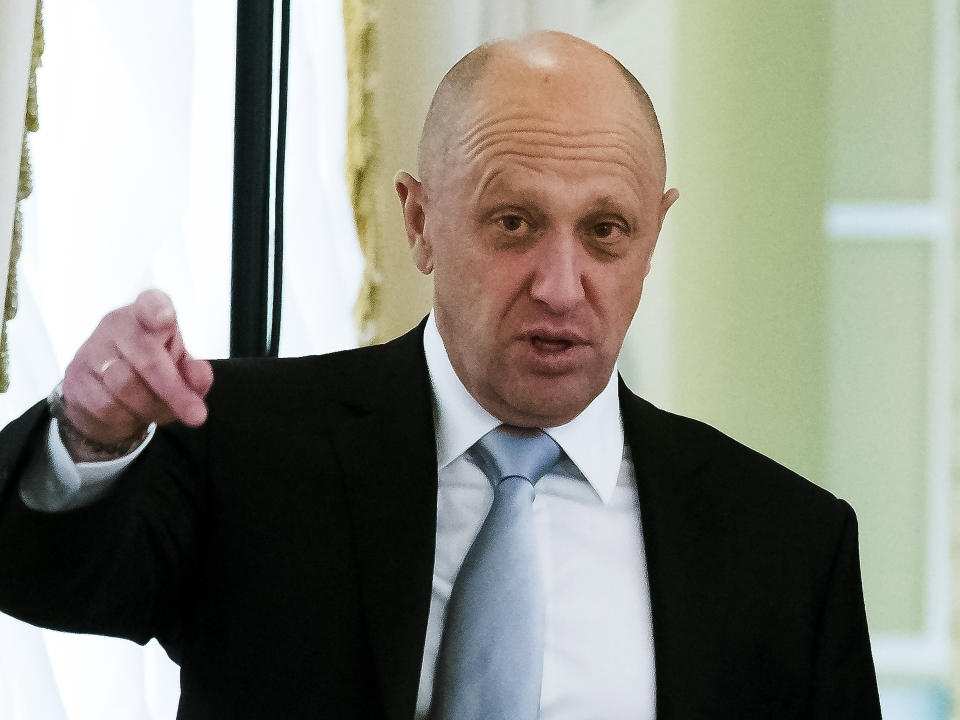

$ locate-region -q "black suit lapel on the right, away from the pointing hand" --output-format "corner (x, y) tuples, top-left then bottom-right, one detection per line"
(620, 381), (729, 719)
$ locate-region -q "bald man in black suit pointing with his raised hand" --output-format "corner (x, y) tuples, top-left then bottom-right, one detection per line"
(0, 33), (880, 720)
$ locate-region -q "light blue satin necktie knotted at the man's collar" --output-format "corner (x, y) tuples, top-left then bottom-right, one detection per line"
(430, 425), (561, 720)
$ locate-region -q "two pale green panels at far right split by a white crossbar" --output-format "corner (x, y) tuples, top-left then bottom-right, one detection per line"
(826, 0), (934, 633)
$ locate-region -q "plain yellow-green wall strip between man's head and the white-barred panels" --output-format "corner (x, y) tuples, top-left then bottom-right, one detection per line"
(672, 0), (831, 482)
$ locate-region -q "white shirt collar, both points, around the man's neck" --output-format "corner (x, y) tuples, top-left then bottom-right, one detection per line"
(423, 313), (623, 502)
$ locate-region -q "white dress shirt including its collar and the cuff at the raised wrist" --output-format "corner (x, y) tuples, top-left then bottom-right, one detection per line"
(20, 314), (655, 720)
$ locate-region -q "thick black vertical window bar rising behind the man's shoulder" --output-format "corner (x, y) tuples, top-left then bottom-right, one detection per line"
(230, 0), (273, 357)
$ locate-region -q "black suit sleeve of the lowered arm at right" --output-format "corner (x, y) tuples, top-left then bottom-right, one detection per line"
(811, 500), (880, 720)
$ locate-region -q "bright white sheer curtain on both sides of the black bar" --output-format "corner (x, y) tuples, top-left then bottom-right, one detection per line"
(0, 0), (361, 720)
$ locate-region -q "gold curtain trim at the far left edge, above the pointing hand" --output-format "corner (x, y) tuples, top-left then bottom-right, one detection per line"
(0, 0), (43, 392)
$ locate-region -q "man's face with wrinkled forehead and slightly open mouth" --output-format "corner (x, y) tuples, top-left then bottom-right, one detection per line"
(398, 56), (673, 427)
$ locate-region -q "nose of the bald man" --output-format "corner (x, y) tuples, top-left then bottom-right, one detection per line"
(530, 234), (586, 314)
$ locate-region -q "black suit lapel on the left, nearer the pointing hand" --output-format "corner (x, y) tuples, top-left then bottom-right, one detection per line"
(333, 324), (437, 720)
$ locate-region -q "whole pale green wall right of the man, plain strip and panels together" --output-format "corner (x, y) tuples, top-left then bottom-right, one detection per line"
(672, 0), (933, 634)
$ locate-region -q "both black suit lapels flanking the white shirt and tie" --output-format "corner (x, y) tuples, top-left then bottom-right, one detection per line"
(332, 344), (726, 720)
